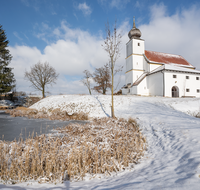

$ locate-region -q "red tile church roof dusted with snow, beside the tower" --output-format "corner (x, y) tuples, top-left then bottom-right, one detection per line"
(145, 50), (194, 67)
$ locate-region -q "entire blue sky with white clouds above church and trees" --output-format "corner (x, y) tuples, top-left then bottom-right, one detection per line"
(0, 0), (200, 94)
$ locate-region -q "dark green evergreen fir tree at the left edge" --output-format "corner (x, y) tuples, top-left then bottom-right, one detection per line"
(0, 25), (15, 94)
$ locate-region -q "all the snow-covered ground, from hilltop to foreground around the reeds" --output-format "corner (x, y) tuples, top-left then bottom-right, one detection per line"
(0, 95), (200, 190)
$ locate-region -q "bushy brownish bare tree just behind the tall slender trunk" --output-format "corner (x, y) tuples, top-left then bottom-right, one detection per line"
(93, 64), (111, 94)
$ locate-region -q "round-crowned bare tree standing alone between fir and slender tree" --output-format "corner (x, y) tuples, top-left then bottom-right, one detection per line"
(24, 62), (58, 98)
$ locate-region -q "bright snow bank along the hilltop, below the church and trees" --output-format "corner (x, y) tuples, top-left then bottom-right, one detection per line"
(30, 95), (200, 118)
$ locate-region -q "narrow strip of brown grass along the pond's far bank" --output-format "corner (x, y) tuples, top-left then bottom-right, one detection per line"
(6, 107), (88, 121)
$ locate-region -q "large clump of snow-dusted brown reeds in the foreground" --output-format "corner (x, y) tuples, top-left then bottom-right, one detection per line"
(0, 118), (146, 183)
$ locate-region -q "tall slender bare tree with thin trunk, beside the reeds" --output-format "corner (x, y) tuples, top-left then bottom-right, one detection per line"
(102, 21), (122, 117)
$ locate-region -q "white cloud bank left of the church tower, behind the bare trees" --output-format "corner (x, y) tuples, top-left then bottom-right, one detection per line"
(10, 21), (128, 94)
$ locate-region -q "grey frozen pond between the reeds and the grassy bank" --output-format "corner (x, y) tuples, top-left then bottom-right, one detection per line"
(0, 112), (85, 141)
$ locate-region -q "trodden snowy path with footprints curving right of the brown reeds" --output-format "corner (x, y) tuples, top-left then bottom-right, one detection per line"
(67, 98), (200, 189)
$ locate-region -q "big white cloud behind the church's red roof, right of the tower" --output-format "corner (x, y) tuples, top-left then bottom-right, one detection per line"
(139, 4), (200, 70)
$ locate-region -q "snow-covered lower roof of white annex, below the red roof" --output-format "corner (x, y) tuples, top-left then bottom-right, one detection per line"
(149, 64), (200, 74)
